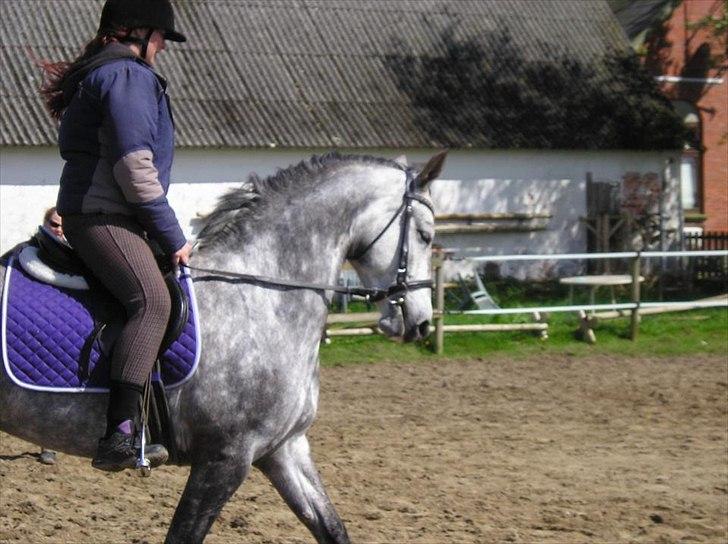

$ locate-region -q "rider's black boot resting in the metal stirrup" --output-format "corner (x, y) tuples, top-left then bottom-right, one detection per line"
(91, 381), (169, 472)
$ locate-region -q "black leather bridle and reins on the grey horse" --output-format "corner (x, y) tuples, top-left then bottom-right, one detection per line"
(187, 169), (435, 306)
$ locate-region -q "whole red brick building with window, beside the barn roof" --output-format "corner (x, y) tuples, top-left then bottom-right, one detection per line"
(612, 0), (728, 231)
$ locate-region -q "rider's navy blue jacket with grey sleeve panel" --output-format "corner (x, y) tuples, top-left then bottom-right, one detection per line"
(57, 44), (186, 254)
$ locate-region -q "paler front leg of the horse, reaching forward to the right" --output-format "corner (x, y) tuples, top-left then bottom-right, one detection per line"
(255, 435), (349, 544)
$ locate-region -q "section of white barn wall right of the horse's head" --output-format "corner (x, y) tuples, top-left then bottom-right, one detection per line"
(433, 151), (679, 278)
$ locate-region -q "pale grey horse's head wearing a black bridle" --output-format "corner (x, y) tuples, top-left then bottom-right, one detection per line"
(351, 152), (447, 341)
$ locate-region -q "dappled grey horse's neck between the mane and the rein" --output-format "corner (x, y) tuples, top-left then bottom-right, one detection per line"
(199, 168), (401, 283)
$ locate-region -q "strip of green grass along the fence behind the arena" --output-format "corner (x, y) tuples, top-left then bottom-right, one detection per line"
(321, 284), (728, 366)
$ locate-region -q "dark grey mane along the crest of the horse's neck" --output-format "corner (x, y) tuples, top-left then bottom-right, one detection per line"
(197, 151), (402, 248)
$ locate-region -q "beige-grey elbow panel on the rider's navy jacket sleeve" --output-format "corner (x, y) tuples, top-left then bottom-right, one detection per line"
(114, 149), (164, 204)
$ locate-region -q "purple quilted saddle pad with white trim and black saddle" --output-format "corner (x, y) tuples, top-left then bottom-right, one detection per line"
(2, 229), (200, 393)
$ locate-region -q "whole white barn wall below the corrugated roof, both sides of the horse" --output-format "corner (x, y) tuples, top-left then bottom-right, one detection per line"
(0, 147), (679, 276)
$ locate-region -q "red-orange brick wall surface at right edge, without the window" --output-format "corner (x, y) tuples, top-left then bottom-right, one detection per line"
(646, 0), (728, 231)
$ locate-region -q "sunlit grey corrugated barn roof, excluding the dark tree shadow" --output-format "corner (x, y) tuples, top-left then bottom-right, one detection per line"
(0, 0), (628, 147)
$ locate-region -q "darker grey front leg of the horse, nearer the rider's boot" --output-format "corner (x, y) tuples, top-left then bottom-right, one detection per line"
(165, 457), (250, 544)
